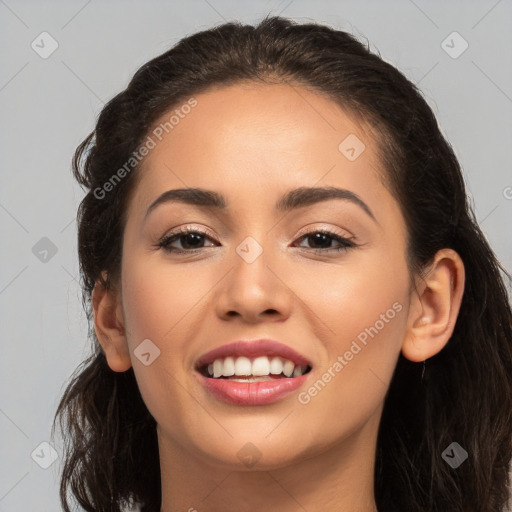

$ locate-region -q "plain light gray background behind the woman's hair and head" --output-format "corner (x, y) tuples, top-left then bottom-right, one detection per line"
(0, 0), (512, 512)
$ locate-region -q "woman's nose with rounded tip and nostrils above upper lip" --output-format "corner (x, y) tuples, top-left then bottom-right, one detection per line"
(215, 241), (293, 323)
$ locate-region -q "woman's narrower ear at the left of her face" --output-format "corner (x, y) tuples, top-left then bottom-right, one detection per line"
(92, 273), (132, 372)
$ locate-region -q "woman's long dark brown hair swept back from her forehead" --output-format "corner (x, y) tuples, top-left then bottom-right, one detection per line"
(54, 17), (512, 512)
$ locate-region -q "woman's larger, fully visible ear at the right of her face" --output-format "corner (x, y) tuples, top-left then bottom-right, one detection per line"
(402, 249), (465, 362)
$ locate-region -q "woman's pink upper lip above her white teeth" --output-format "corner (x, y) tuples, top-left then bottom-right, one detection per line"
(196, 339), (312, 369)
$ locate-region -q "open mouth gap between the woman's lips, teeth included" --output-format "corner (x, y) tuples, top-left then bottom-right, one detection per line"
(198, 356), (311, 382)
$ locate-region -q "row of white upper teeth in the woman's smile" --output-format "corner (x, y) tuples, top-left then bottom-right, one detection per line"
(204, 356), (308, 382)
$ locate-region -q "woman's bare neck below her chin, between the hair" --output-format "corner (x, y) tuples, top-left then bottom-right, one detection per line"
(158, 412), (379, 512)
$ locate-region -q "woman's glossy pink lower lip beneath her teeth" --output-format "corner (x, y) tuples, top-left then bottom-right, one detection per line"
(197, 372), (311, 405)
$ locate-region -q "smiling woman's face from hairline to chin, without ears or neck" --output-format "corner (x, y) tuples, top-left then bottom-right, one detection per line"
(120, 84), (410, 468)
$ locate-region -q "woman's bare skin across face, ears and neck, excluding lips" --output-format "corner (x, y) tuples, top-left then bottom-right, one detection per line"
(93, 84), (464, 512)
